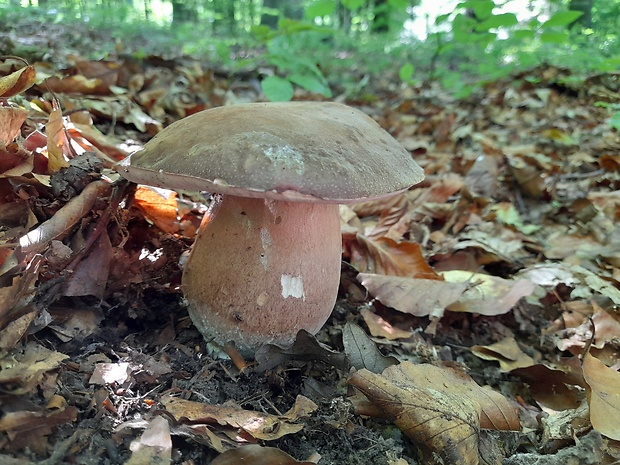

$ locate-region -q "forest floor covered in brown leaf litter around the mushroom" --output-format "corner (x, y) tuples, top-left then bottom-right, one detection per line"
(0, 16), (620, 465)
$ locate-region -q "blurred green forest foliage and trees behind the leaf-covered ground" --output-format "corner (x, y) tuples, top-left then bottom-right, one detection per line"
(0, 0), (620, 100)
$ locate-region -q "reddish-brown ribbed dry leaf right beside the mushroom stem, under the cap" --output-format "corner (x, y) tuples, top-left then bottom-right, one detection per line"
(350, 234), (442, 280)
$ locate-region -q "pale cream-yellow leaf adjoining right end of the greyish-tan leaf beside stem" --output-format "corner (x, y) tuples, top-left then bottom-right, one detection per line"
(442, 270), (536, 316)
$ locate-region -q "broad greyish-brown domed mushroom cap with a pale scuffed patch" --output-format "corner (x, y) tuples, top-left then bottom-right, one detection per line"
(119, 102), (424, 203)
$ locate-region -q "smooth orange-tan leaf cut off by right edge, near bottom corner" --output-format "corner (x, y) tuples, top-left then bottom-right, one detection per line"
(583, 353), (620, 441)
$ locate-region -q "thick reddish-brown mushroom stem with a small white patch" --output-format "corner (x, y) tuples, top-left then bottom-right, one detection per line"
(183, 195), (341, 353)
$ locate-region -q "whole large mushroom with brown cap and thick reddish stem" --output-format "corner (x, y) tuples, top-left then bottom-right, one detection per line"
(117, 102), (424, 354)
